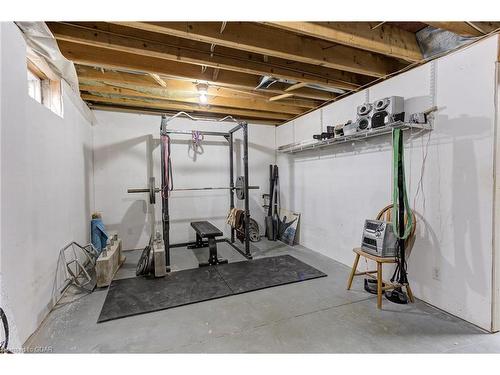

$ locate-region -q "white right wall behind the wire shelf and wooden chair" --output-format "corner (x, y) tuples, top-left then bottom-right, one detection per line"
(276, 36), (498, 329)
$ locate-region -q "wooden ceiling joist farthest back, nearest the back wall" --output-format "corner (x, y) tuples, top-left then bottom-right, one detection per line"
(81, 94), (293, 120)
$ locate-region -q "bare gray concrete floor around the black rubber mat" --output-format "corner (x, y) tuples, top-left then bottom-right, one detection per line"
(27, 240), (500, 353)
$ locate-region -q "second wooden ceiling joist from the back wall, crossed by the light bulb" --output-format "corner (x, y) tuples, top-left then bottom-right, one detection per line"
(80, 84), (304, 115)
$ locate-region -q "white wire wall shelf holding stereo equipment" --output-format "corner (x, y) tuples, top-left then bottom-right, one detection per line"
(278, 121), (432, 154)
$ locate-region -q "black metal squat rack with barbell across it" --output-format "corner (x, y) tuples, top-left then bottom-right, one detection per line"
(127, 112), (259, 272)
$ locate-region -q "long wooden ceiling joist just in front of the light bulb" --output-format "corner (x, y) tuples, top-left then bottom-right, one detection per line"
(58, 41), (336, 101)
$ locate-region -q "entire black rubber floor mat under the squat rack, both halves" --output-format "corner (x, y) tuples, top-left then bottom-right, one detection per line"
(97, 255), (326, 323)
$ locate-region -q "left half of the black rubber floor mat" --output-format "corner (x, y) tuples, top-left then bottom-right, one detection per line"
(97, 267), (232, 323)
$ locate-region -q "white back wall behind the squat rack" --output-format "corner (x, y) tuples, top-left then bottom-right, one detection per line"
(93, 111), (275, 254)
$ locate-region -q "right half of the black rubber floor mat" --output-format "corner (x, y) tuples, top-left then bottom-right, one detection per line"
(217, 255), (326, 294)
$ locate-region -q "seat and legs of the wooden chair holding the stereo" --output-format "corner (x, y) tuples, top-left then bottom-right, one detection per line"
(347, 247), (415, 309)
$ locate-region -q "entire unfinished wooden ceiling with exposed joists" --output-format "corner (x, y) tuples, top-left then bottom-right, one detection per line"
(47, 22), (500, 124)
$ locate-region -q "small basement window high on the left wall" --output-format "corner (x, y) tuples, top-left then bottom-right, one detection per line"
(27, 51), (63, 117)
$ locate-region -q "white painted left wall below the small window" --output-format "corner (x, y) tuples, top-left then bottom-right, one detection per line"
(0, 23), (93, 348)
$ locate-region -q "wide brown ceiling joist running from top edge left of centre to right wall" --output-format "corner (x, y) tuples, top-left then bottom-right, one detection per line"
(116, 22), (405, 77)
